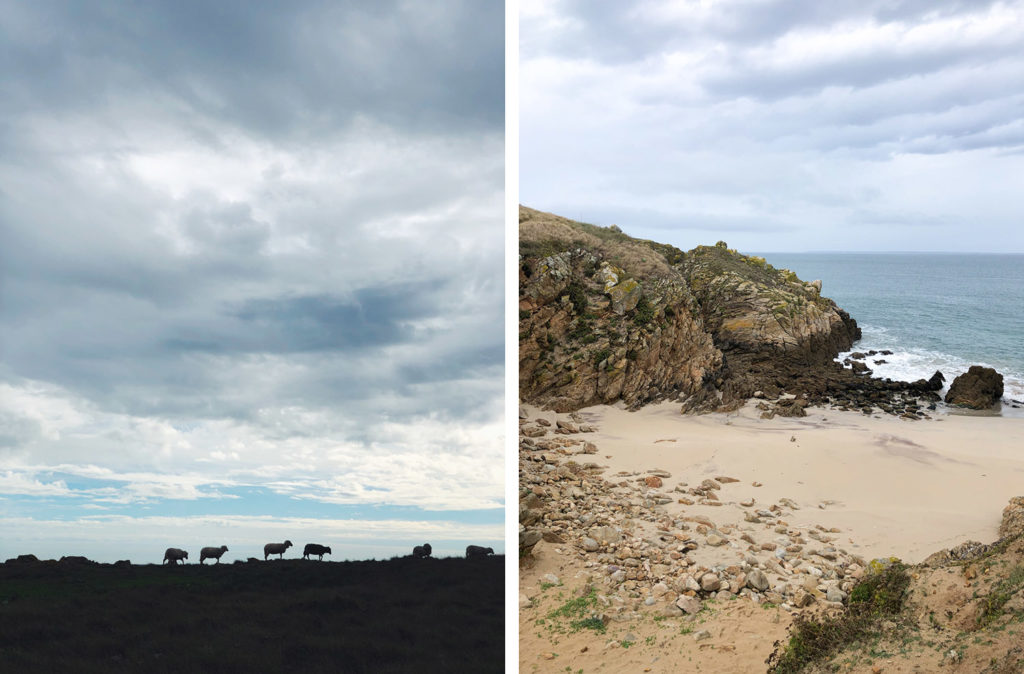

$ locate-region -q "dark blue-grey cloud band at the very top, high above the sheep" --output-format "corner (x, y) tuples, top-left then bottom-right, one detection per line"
(0, 0), (504, 138)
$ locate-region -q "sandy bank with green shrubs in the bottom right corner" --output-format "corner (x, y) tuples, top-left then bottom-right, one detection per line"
(770, 534), (1024, 674)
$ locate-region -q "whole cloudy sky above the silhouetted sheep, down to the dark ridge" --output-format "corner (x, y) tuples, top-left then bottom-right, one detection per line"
(0, 0), (504, 562)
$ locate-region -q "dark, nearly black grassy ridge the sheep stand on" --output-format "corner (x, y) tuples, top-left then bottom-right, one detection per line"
(0, 555), (505, 673)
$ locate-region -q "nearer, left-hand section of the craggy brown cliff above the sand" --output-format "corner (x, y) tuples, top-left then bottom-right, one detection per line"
(519, 208), (722, 412)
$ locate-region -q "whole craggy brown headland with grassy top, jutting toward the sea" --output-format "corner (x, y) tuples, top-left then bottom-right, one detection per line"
(519, 207), (872, 412)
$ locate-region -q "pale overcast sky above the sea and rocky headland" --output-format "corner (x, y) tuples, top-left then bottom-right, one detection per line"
(519, 0), (1024, 253)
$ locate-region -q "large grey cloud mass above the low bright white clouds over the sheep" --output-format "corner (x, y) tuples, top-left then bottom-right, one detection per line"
(0, 0), (504, 436)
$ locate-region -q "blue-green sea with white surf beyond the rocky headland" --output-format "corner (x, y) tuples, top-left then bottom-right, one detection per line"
(758, 253), (1024, 417)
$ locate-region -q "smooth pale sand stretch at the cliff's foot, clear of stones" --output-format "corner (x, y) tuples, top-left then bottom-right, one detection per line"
(530, 403), (1024, 562)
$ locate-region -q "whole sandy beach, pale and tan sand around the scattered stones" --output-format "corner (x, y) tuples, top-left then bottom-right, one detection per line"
(519, 402), (1024, 672)
